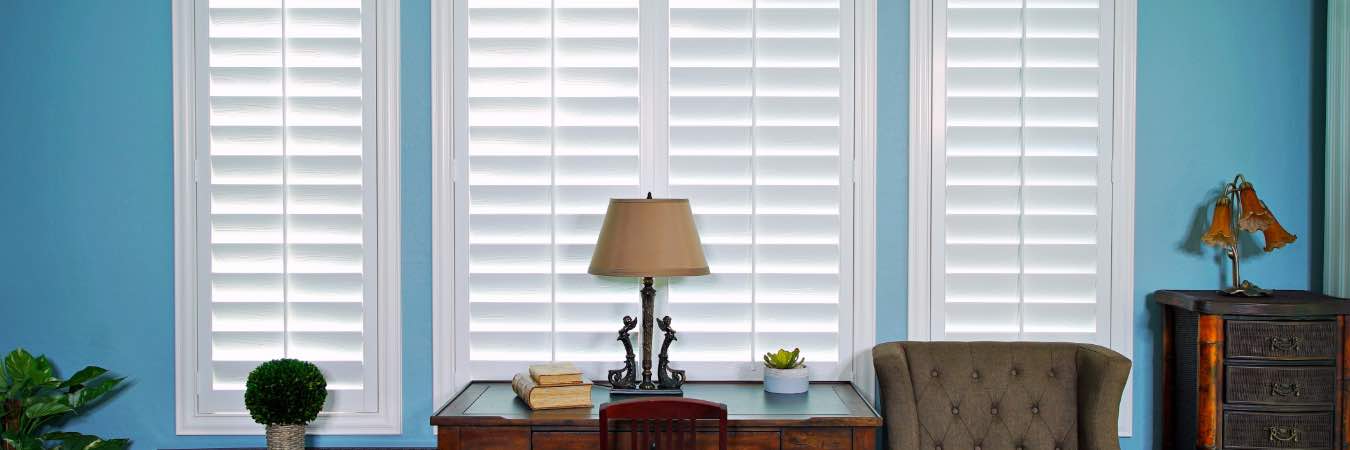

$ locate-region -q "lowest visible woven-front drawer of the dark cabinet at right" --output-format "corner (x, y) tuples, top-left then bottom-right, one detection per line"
(1223, 411), (1335, 449)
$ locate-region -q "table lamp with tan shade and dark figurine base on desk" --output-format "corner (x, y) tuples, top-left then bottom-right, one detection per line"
(586, 193), (709, 395)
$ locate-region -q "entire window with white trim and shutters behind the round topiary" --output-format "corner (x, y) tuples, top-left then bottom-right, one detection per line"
(174, 0), (402, 434)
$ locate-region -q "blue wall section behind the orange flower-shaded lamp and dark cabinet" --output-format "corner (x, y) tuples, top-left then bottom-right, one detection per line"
(1126, 0), (1326, 449)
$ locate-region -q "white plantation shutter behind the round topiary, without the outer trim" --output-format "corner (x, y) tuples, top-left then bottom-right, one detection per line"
(197, 0), (379, 414)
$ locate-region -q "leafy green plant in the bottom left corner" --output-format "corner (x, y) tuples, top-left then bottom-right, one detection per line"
(0, 349), (131, 450)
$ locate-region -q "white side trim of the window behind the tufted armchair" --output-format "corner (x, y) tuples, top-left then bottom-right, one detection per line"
(909, 0), (1138, 436)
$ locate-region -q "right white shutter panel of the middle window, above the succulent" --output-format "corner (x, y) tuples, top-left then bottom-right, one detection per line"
(667, 0), (845, 378)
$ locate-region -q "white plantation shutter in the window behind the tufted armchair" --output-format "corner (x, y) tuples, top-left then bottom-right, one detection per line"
(932, 0), (1127, 345)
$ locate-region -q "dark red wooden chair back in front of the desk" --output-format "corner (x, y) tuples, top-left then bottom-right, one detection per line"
(599, 397), (726, 450)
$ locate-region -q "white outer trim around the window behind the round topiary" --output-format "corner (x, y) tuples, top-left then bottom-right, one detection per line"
(173, 0), (404, 435)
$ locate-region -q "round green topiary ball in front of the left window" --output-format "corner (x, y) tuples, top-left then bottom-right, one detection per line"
(244, 358), (328, 424)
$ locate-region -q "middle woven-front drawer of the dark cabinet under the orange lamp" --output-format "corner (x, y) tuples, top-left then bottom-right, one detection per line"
(1224, 366), (1337, 405)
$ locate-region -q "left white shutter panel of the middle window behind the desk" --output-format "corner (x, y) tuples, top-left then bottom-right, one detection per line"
(466, 0), (641, 380)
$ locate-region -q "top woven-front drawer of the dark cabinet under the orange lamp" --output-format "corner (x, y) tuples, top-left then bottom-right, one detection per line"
(1226, 320), (1338, 361)
